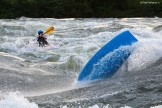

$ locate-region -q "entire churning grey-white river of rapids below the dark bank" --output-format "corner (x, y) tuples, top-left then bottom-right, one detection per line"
(0, 17), (162, 108)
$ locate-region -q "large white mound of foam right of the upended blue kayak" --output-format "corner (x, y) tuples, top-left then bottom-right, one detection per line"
(128, 39), (162, 71)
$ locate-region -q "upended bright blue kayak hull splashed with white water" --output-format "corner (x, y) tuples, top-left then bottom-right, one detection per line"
(78, 31), (138, 81)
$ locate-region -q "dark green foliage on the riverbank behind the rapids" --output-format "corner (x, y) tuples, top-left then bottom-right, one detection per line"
(0, 0), (162, 18)
